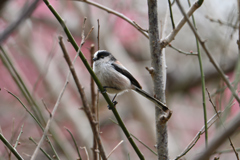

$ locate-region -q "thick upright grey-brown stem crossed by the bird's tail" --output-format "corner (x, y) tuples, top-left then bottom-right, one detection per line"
(148, 0), (168, 160)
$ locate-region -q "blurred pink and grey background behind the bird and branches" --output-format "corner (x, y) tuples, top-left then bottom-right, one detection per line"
(0, 0), (240, 160)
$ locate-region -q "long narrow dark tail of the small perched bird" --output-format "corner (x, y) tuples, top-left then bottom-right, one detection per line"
(134, 87), (169, 112)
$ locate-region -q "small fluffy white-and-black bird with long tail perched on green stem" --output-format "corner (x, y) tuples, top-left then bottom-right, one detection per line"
(93, 50), (168, 111)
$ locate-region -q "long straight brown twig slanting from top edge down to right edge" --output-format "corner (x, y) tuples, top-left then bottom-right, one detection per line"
(176, 0), (240, 104)
